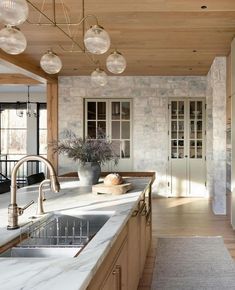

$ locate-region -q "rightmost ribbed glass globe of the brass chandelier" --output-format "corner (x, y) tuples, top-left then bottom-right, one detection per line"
(106, 50), (126, 74)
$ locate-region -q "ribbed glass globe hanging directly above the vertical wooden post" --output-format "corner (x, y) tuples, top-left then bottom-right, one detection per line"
(40, 50), (62, 74)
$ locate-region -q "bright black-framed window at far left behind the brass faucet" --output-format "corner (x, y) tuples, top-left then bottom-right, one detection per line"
(0, 103), (47, 184)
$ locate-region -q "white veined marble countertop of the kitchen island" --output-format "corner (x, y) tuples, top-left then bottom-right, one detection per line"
(0, 177), (151, 290)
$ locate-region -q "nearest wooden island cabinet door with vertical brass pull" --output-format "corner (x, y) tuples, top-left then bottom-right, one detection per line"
(101, 241), (129, 290)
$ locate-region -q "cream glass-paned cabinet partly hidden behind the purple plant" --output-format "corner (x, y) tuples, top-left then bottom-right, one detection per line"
(85, 99), (132, 171)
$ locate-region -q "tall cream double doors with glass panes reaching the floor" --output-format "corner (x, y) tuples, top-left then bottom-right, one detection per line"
(168, 99), (206, 196)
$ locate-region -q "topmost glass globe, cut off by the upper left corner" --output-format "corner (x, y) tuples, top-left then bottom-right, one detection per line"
(0, 0), (29, 26)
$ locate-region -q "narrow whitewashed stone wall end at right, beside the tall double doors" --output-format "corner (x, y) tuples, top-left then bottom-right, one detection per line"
(207, 57), (226, 214)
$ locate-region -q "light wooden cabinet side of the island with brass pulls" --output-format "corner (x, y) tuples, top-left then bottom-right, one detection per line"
(87, 187), (151, 290)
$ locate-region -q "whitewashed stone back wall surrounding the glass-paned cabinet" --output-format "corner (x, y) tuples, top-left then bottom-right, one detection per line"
(59, 76), (206, 195)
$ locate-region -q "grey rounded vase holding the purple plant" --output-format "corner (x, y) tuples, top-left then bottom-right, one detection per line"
(78, 162), (101, 186)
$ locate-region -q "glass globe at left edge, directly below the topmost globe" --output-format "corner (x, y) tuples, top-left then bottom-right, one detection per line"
(0, 25), (27, 54)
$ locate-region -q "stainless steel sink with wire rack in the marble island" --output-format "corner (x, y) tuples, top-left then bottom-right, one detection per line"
(0, 212), (112, 258)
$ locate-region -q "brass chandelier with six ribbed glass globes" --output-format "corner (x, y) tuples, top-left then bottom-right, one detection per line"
(0, 0), (126, 86)
